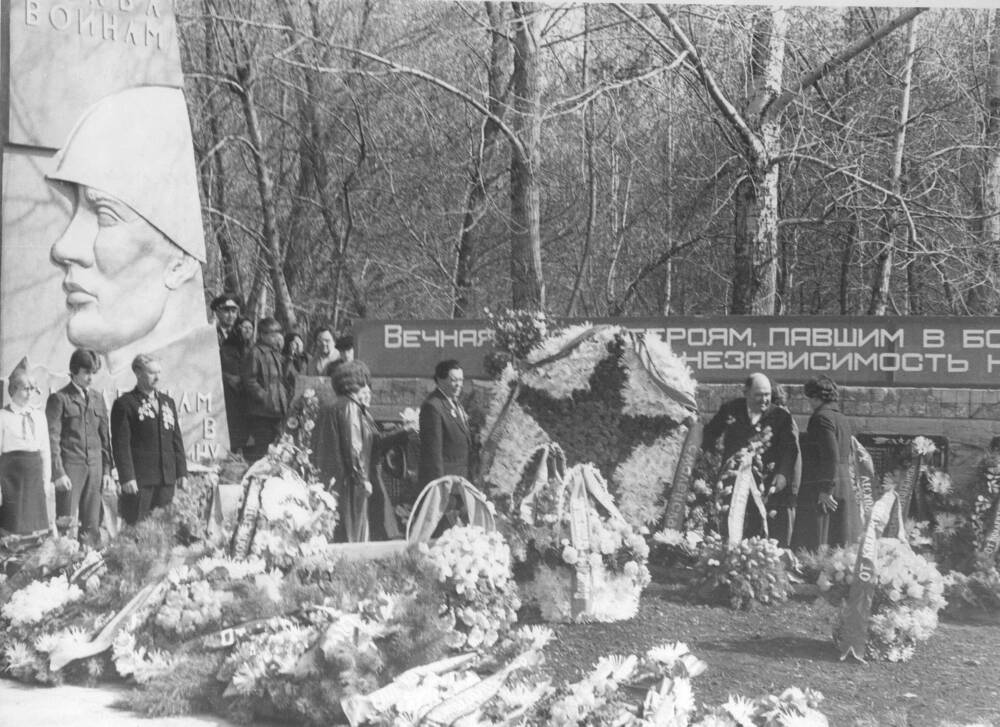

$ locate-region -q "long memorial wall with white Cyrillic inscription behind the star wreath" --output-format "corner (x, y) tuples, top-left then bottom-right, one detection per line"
(355, 316), (1000, 492)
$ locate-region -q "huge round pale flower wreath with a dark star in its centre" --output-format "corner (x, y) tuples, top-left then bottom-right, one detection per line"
(482, 325), (696, 527)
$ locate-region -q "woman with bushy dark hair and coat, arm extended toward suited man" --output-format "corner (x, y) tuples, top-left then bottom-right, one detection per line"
(313, 361), (408, 543)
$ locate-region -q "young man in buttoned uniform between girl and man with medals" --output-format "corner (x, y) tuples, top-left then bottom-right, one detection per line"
(45, 348), (114, 544)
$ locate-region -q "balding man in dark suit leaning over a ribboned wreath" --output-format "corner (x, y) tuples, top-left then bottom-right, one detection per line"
(702, 373), (799, 546)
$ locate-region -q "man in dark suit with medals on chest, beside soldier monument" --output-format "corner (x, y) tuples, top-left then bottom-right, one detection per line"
(111, 354), (187, 525)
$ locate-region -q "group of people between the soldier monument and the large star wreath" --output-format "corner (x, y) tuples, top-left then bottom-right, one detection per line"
(211, 295), (473, 542)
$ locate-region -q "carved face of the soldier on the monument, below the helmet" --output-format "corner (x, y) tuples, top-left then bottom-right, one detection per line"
(51, 185), (179, 352)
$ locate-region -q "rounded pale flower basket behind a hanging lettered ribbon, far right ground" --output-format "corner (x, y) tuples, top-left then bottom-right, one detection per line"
(813, 538), (945, 661)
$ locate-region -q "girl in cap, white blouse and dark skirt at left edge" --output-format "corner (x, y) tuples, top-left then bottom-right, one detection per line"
(0, 361), (55, 535)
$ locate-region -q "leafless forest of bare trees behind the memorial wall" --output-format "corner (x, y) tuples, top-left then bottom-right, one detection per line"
(177, 0), (1000, 328)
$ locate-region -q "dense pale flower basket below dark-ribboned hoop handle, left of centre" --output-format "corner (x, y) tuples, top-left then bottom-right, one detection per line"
(420, 526), (521, 649)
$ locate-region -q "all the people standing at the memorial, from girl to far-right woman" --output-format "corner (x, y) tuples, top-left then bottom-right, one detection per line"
(0, 288), (861, 549)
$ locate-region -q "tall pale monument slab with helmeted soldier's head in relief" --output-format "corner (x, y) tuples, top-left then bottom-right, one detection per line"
(0, 0), (228, 460)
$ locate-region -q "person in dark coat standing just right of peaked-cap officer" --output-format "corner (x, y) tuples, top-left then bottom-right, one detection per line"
(240, 318), (291, 460)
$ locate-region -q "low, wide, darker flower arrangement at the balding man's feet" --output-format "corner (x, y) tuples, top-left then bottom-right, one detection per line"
(693, 533), (791, 609)
